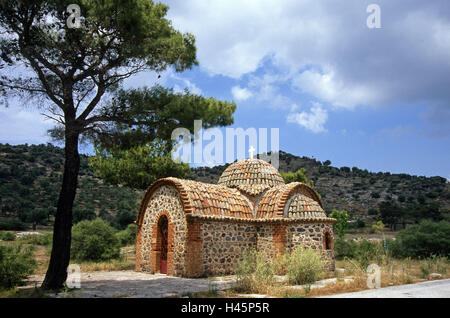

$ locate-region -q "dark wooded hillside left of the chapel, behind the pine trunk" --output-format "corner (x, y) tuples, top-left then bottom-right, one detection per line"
(0, 144), (142, 228)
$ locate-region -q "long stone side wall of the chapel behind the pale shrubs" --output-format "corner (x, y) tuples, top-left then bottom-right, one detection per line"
(182, 218), (334, 277)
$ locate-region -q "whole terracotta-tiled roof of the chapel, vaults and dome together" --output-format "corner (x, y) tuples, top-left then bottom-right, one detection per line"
(136, 159), (334, 224)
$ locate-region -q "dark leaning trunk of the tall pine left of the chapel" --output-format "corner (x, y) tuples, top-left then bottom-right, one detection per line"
(41, 126), (80, 289)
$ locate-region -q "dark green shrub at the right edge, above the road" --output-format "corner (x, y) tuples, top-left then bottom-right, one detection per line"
(397, 220), (450, 258)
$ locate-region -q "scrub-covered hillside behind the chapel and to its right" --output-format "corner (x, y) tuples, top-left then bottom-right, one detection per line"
(191, 151), (450, 218)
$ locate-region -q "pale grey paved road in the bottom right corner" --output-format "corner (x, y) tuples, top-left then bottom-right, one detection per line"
(322, 279), (450, 298)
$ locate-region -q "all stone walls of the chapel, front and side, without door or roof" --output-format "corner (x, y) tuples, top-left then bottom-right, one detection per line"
(136, 185), (334, 277)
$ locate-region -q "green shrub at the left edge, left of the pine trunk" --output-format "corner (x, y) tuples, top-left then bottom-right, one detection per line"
(0, 245), (36, 289)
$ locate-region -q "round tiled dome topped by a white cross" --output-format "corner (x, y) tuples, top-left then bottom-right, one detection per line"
(217, 159), (284, 196)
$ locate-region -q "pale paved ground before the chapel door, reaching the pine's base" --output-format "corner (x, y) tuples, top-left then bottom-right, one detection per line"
(26, 271), (234, 298)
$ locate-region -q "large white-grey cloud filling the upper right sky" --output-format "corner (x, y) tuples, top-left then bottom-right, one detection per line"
(165, 0), (450, 112)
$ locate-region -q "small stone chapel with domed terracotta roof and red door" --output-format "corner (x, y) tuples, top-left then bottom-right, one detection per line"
(136, 159), (336, 277)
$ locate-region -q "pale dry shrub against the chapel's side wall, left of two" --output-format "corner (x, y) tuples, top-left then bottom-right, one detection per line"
(235, 249), (276, 293)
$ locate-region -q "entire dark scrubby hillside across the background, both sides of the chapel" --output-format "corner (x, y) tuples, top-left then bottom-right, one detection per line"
(0, 144), (450, 228)
